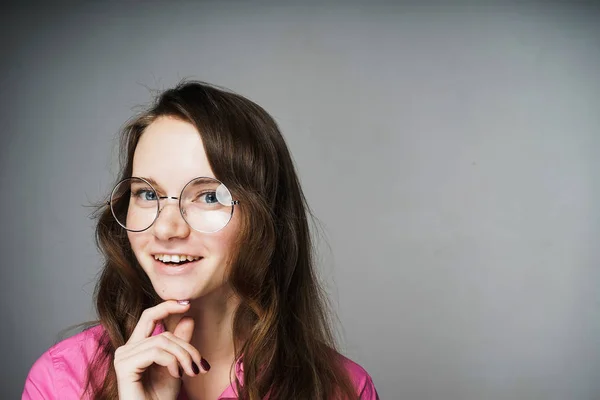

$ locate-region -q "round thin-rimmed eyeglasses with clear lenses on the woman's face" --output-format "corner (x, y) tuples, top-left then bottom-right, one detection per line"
(108, 177), (239, 233)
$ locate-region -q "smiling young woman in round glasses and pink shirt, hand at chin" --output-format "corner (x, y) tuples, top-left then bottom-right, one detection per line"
(23, 82), (378, 400)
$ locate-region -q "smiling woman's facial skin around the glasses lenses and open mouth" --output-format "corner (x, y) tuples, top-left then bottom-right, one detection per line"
(128, 117), (239, 300)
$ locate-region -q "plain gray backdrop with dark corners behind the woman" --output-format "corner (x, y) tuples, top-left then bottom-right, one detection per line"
(0, 1), (600, 400)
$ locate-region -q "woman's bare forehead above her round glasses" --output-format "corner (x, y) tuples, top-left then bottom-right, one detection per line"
(132, 117), (214, 190)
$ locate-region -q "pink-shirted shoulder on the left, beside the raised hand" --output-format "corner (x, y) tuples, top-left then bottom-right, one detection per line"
(22, 325), (104, 400)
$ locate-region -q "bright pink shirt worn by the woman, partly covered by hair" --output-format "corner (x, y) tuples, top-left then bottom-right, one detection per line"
(21, 324), (379, 400)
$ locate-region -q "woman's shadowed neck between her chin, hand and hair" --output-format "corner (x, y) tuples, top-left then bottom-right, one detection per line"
(165, 286), (239, 365)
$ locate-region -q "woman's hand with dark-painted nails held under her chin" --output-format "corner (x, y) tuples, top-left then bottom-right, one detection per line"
(114, 300), (206, 400)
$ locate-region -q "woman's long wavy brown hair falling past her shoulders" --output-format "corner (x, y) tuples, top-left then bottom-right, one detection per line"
(86, 81), (358, 400)
